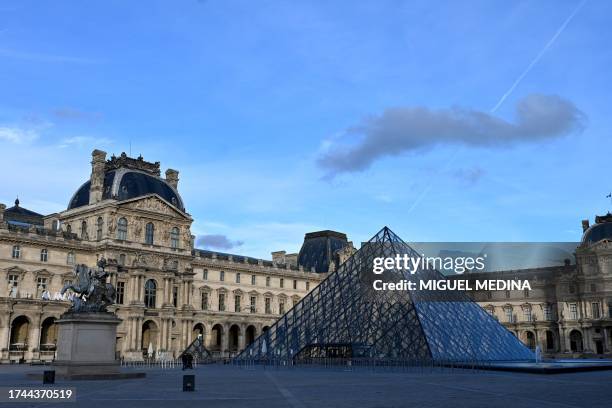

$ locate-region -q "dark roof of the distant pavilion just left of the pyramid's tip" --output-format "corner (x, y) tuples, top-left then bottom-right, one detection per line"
(298, 230), (348, 273)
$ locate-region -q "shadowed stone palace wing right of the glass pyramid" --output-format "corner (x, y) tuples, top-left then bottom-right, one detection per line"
(463, 213), (612, 358)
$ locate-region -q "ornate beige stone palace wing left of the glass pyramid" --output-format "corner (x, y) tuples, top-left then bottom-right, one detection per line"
(0, 150), (352, 363)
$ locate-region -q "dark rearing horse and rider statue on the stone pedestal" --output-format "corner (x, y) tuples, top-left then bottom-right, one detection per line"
(61, 258), (116, 312)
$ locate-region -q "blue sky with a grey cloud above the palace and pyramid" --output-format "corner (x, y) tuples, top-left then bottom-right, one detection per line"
(0, 0), (612, 257)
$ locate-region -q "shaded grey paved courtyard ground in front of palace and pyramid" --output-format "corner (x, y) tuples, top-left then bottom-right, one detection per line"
(0, 365), (612, 408)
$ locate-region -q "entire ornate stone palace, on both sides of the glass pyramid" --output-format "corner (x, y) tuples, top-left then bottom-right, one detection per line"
(0, 150), (612, 363)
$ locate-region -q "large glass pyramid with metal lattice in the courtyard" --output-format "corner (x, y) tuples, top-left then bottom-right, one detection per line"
(236, 227), (534, 361)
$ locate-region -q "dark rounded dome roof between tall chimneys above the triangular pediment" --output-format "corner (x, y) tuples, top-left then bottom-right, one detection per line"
(68, 168), (185, 211)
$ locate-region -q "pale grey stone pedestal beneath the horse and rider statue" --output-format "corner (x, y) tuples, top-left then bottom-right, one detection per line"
(53, 313), (143, 380)
